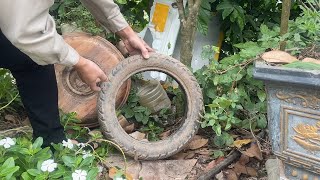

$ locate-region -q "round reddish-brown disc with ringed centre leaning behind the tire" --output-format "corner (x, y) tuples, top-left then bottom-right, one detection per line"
(55, 33), (131, 127)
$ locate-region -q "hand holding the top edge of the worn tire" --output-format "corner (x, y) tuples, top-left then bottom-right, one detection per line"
(117, 26), (154, 59)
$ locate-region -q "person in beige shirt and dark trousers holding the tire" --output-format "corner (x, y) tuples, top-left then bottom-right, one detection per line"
(0, 0), (152, 146)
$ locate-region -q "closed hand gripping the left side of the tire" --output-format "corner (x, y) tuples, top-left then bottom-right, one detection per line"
(73, 57), (108, 91)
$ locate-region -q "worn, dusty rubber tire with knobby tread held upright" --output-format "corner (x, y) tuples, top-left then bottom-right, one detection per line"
(98, 53), (203, 160)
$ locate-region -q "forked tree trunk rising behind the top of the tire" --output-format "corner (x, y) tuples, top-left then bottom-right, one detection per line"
(177, 0), (202, 66)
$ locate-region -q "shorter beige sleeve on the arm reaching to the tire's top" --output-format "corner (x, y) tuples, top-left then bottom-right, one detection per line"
(81, 0), (129, 33)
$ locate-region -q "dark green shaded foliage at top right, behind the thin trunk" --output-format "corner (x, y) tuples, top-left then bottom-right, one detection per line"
(211, 0), (300, 54)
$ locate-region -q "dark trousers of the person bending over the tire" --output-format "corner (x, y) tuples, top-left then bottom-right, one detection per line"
(0, 31), (65, 146)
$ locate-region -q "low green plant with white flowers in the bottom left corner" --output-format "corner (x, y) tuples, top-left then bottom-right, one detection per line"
(0, 137), (100, 180)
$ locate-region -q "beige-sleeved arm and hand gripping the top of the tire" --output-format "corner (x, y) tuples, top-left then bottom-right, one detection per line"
(81, 0), (153, 58)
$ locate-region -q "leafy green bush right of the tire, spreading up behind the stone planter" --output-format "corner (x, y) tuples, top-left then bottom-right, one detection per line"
(196, 1), (320, 146)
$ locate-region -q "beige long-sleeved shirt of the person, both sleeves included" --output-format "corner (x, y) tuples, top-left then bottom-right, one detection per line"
(0, 0), (128, 66)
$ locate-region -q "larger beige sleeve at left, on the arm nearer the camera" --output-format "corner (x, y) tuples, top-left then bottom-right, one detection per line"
(0, 0), (79, 66)
